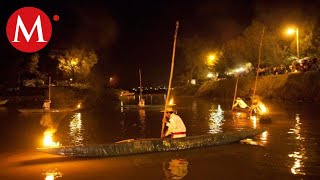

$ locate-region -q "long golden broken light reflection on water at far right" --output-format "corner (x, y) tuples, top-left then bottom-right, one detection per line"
(288, 114), (307, 175)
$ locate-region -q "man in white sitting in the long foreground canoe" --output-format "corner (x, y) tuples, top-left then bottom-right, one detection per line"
(162, 107), (187, 138)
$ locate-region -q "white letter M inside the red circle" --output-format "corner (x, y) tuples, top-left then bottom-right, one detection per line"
(12, 15), (47, 42)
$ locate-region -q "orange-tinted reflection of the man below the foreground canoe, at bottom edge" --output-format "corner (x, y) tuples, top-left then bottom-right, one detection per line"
(163, 159), (188, 179)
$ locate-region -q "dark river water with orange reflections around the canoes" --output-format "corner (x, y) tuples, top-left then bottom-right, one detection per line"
(0, 95), (320, 179)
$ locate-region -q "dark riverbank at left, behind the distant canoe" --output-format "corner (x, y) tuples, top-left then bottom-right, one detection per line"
(2, 86), (119, 108)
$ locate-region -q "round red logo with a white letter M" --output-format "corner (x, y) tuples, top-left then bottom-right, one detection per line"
(7, 7), (52, 53)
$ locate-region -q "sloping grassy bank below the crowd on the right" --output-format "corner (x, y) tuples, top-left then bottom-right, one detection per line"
(196, 71), (320, 102)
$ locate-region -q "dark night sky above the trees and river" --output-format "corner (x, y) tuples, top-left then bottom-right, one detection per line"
(0, 0), (319, 87)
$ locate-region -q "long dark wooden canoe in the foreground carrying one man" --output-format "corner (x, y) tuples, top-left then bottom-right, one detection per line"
(37, 129), (265, 157)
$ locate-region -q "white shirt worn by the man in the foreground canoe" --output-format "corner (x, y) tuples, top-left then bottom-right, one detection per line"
(165, 113), (187, 138)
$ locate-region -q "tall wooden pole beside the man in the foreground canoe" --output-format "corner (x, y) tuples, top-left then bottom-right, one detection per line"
(160, 21), (179, 137)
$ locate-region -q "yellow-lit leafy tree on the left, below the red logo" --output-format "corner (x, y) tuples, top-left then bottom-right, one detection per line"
(50, 48), (98, 81)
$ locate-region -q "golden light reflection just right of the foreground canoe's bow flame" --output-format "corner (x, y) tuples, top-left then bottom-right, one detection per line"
(69, 113), (84, 146)
